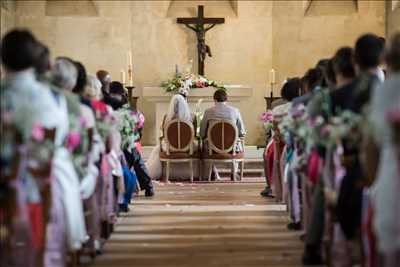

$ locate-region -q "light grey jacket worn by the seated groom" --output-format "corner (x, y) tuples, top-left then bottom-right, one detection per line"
(200, 102), (246, 139)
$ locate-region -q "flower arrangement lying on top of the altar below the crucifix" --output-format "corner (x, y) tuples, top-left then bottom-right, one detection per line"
(161, 74), (225, 92)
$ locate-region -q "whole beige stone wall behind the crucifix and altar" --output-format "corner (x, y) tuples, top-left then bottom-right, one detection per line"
(7, 0), (385, 147)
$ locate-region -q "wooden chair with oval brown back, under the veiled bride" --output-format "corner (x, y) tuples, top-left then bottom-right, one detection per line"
(160, 119), (200, 182)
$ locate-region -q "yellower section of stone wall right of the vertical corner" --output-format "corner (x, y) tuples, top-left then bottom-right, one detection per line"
(272, 1), (385, 91)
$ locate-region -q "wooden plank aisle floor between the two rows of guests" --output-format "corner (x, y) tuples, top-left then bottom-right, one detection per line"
(85, 183), (302, 267)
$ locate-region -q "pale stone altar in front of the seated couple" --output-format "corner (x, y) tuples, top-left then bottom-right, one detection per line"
(142, 85), (253, 137)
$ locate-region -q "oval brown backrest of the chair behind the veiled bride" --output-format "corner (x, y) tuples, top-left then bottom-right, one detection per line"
(164, 119), (194, 153)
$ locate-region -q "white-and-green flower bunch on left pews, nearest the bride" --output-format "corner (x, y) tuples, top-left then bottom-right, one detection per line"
(114, 105), (144, 151)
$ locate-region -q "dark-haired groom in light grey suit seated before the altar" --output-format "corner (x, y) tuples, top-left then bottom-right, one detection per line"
(200, 89), (246, 180)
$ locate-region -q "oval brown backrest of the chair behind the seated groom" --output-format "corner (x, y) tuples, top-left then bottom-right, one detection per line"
(207, 120), (238, 154)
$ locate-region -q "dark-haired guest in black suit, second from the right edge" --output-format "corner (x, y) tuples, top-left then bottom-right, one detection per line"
(331, 34), (384, 248)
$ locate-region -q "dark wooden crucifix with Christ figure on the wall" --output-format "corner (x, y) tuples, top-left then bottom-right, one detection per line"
(177, 6), (225, 75)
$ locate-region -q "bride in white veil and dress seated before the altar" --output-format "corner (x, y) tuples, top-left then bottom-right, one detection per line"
(146, 94), (198, 179)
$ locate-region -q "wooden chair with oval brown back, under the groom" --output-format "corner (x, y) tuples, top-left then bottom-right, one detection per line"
(203, 120), (244, 181)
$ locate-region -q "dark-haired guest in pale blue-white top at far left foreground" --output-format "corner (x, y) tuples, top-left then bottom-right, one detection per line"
(0, 29), (44, 267)
